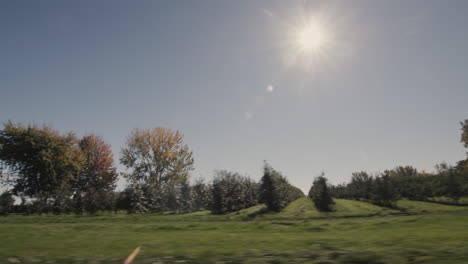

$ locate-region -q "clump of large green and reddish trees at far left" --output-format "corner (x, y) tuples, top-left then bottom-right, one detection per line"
(0, 122), (118, 213)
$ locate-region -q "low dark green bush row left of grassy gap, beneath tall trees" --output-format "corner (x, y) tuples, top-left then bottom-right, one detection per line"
(0, 164), (304, 214)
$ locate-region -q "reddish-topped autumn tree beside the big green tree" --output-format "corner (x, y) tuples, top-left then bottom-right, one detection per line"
(73, 135), (118, 213)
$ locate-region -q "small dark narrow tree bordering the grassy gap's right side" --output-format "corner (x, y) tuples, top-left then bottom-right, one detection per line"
(309, 172), (335, 212)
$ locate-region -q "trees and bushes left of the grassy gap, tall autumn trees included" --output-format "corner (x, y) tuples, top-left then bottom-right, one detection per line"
(0, 122), (304, 214)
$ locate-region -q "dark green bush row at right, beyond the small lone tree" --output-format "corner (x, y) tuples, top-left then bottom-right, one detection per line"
(330, 161), (468, 206)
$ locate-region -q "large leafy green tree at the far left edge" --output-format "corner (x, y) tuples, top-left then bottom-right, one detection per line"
(0, 122), (82, 211)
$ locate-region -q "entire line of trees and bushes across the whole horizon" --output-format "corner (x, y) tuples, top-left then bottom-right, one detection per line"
(0, 119), (468, 214)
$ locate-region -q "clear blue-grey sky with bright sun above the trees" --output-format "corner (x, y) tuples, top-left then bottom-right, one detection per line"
(0, 0), (468, 191)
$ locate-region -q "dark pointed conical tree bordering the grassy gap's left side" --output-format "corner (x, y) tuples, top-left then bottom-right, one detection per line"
(260, 163), (304, 211)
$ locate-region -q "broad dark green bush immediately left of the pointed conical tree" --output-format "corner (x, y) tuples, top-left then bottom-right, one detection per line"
(211, 170), (259, 214)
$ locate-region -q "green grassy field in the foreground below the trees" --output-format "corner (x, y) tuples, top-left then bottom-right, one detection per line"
(0, 198), (468, 264)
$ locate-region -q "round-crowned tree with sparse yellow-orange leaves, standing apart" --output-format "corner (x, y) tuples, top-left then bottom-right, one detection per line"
(120, 127), (194, 212)
